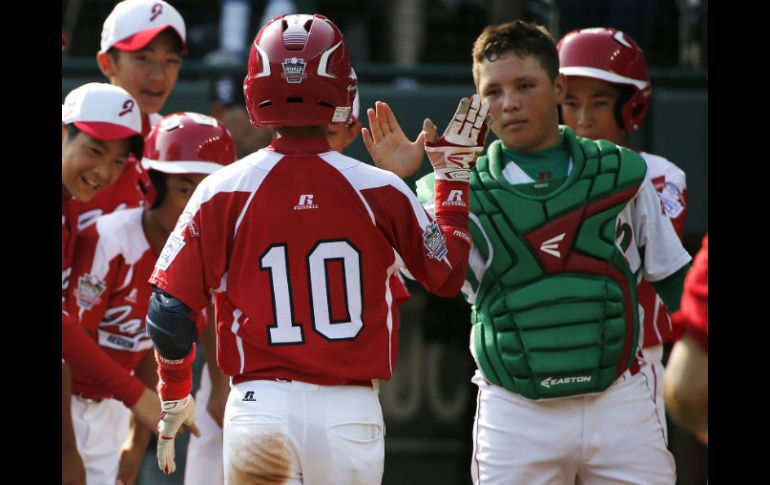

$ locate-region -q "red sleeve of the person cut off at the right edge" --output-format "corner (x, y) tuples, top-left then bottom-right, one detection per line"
(674, 234), (709, 352)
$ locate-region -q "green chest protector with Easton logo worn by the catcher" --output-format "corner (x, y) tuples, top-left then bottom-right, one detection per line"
(416, 127), (647, 399)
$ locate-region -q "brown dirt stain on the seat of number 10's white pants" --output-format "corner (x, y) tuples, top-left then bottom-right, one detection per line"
(229, 432), (292, 485)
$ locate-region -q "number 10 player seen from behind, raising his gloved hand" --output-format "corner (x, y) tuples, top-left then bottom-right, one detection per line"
(147, 15), (486, 484)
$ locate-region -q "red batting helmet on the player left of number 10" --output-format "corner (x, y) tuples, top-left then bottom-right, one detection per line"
(142, 113), (236, 174)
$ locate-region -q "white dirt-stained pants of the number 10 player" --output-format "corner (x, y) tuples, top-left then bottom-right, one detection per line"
(224, 380), (385, 485)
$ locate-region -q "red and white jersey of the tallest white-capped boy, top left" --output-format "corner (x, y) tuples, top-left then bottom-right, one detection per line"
(78, 113), (162, 231)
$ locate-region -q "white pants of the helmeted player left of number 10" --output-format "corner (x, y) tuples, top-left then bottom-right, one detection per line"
(71, 396), (131, 485)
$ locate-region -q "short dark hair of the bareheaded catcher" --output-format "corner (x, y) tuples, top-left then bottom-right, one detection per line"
(473, 20), (559, 86)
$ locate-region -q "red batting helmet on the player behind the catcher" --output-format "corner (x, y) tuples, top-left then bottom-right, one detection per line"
(556, 27), (652, 133)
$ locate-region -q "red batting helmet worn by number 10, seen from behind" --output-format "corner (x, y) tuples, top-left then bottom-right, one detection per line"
(243, 14), (358, 126)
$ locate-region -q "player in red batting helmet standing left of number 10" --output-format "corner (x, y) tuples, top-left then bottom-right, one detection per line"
(67, 113), (235, 484)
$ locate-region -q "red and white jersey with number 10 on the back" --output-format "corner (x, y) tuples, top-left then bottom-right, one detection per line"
(150, 137), (470, 392)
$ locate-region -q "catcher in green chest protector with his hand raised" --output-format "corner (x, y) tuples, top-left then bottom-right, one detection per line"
(367, 20), (691, 485)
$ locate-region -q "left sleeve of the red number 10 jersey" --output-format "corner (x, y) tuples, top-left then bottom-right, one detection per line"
(150, 181), (250, 312)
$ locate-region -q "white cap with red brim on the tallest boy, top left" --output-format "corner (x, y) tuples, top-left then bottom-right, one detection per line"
(101, 0), (187, 52)
